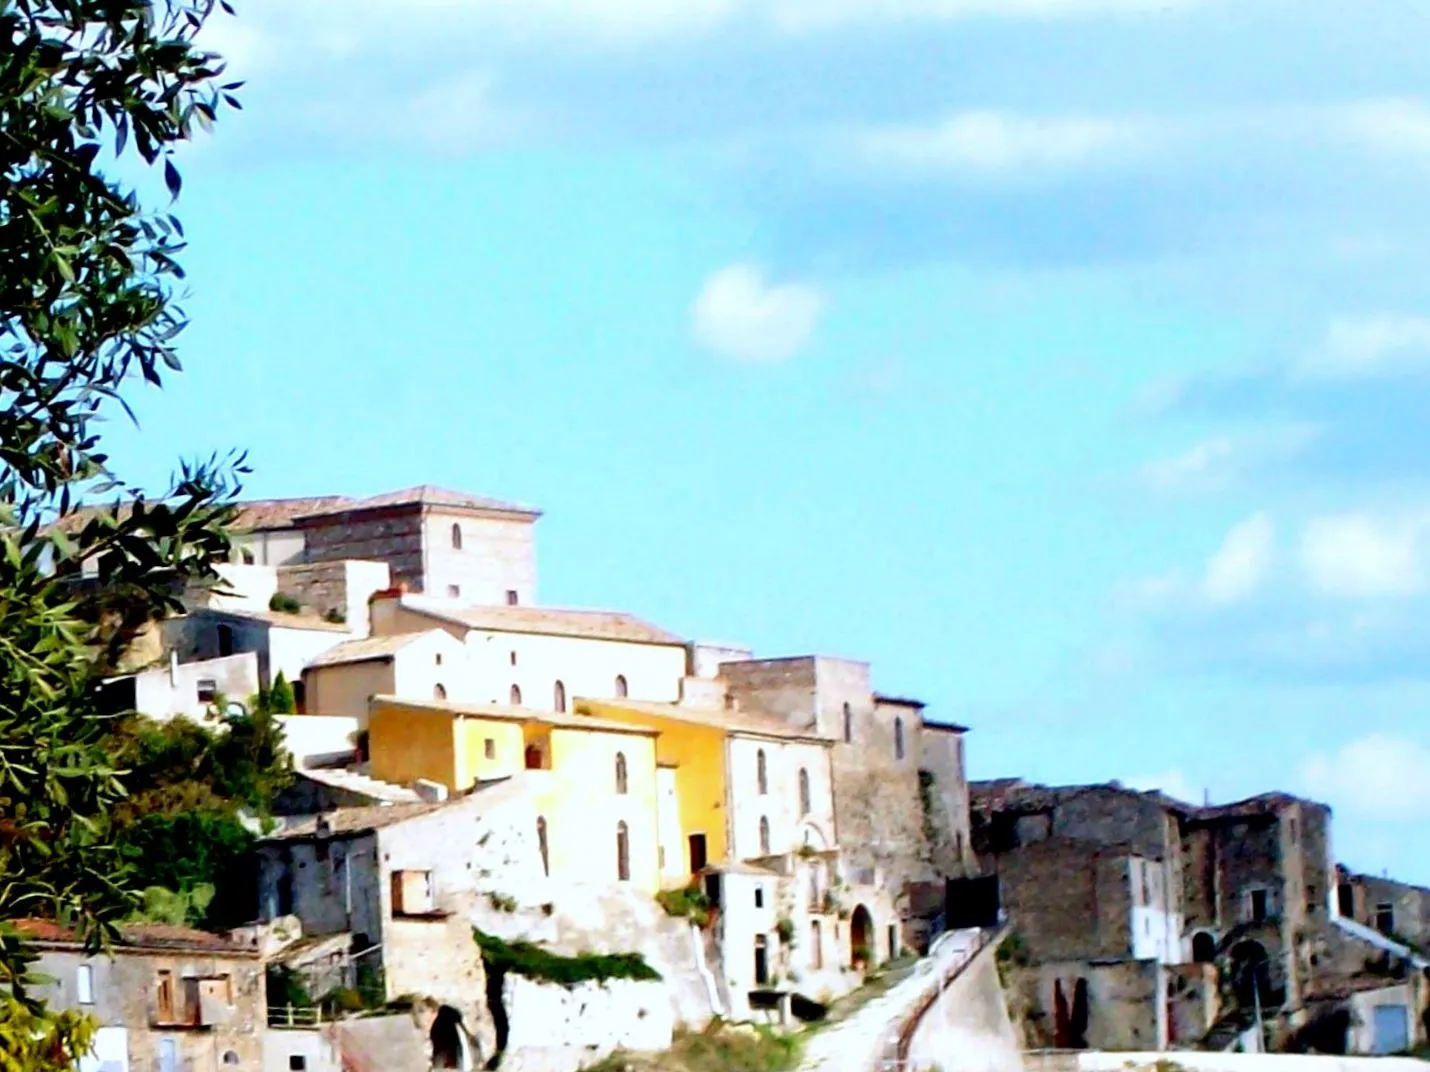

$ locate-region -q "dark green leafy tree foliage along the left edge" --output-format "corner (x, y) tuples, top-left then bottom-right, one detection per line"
(0, 0), (242, 1072)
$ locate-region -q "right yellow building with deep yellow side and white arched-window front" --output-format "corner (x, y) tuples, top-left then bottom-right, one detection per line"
(576, 699), (835, 886)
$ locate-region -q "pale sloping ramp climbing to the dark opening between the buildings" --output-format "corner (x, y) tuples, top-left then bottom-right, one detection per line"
(799, 930), (982, 1072)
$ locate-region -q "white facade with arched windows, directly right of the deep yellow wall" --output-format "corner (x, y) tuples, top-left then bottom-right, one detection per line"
(728, 736), (835, 859)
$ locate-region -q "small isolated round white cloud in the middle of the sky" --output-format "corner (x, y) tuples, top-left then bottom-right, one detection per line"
(691, 264), (825, 362)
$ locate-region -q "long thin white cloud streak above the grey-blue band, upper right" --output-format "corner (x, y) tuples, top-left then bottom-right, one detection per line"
(854, 111), (1154, 174)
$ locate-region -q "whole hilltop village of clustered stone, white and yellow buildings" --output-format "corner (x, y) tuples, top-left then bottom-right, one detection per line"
(23, 486), (1430, 1072)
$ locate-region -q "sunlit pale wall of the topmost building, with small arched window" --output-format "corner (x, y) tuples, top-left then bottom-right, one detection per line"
(422, 507), (536, 606)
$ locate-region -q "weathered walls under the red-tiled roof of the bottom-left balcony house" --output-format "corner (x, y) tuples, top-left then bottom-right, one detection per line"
(33, 948), (267, 1072)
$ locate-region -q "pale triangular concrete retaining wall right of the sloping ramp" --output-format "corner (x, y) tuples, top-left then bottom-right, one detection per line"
(908, 931), (1022, 1072)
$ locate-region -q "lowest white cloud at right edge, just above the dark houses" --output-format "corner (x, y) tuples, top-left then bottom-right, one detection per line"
(1301, 733), (1430, 822)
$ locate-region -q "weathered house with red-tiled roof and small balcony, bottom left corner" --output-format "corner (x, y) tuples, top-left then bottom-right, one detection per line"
(19, 920), (265, 1072)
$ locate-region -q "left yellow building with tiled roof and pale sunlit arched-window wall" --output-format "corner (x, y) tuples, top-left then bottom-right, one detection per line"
(368, 696), (661, 893)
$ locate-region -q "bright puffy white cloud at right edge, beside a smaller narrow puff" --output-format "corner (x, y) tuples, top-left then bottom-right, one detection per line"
(1301, 513), (1430, 599)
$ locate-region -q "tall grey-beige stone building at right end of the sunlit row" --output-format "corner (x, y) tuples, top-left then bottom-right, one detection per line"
(719, 656), (974, 890)
